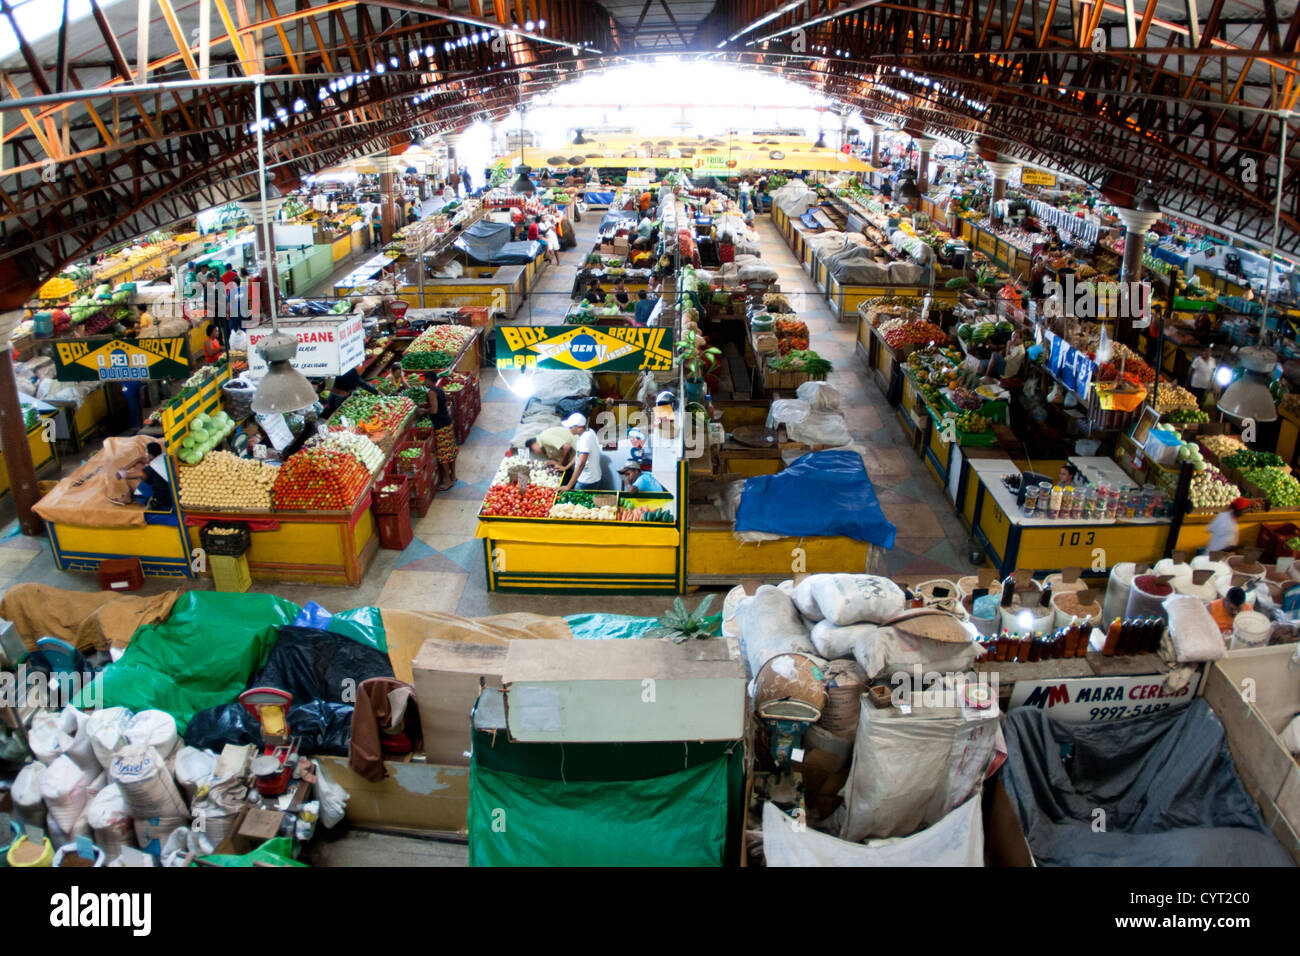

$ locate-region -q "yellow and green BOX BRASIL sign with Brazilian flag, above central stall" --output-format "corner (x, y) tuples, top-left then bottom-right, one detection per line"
(497, 325), (672, 372)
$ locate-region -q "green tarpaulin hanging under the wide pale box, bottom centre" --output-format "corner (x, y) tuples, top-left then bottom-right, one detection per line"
(468, 757), (728, 866)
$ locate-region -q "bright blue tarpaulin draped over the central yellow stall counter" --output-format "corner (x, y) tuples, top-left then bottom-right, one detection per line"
(736, 449), (896, 548)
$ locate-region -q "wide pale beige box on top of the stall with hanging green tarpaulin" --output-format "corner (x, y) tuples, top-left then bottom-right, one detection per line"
(503, 637), (745, 743)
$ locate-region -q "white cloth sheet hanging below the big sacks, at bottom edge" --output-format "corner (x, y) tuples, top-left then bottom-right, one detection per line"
(763, 796), (984, 866)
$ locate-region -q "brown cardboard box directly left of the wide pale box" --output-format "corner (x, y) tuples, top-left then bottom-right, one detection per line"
(411, 637), (506, 766)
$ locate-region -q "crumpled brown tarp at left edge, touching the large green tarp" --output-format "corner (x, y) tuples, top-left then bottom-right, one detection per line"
(0, 584), (183, 655)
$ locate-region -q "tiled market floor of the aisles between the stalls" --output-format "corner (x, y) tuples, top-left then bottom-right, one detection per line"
(0, 213), (971, 617)
